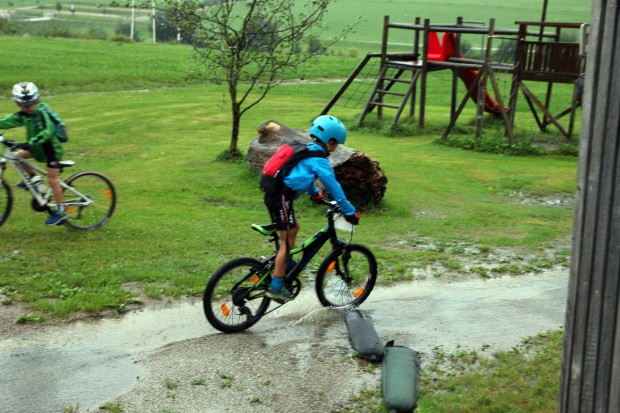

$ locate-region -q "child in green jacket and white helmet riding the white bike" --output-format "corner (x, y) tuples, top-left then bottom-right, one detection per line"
(0, 82), (68, 225)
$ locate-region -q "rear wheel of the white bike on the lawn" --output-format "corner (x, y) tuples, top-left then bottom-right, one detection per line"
(63, 171), (116, 230)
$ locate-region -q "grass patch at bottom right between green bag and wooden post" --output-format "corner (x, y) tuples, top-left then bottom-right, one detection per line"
(333, 331), (562, 413)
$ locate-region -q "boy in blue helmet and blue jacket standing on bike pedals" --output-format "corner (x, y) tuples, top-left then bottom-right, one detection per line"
(265, 115), (359, 301)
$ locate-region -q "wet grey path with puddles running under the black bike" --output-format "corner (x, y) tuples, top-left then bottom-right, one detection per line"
(0, 269), (568, 413)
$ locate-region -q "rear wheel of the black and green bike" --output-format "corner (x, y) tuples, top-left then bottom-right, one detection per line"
(202, 257), (271, 333)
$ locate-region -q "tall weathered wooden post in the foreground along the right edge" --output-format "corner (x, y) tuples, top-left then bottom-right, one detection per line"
(558, 0), (620, 413)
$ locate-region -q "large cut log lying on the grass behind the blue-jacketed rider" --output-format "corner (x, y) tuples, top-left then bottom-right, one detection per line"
(247, 120), (387, 210)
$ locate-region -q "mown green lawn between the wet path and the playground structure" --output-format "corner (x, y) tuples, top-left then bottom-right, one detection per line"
(0, 75), (576, 316)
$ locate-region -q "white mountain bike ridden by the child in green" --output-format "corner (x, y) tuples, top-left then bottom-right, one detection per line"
(0, 132), (116, 230)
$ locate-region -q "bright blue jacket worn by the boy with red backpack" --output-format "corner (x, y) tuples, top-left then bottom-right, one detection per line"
(283, 142), (355, 215)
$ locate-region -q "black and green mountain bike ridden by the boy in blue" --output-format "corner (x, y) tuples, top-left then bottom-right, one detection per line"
(202, 201), (377, 333)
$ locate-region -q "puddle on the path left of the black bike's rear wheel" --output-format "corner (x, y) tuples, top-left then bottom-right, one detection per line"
(0, 303), (214, 413)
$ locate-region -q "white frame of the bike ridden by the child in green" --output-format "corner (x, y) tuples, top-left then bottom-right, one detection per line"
(0, 137), (93, 208)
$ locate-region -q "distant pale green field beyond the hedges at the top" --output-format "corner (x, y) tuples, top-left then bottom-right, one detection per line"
(0, 0), (591, 53)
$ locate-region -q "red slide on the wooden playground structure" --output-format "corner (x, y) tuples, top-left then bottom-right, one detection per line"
(428, 32), (508, 115)
